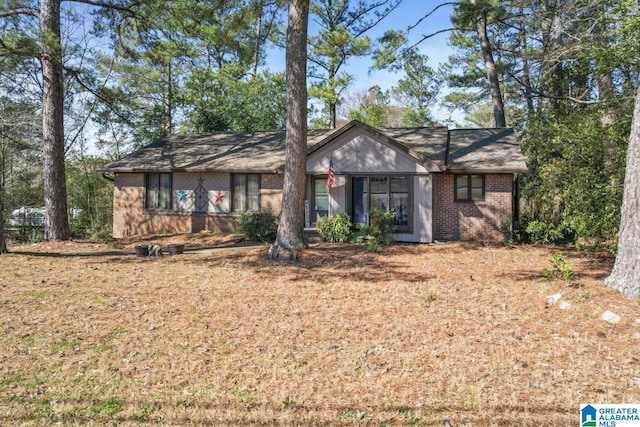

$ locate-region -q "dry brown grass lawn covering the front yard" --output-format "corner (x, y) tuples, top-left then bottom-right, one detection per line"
(0, 235), (640, 427)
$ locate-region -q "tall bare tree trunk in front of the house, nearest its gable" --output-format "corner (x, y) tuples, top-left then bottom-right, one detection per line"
(276, 0), (309, 249)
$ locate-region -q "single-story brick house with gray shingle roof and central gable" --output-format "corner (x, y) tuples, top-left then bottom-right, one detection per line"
(102, 121), (527, 243)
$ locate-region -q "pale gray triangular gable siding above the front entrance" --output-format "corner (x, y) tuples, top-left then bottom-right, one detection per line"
(307, 132), (428, 174)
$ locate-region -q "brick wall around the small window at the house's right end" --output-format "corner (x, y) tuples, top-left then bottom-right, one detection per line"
(433, 174), (513, 241)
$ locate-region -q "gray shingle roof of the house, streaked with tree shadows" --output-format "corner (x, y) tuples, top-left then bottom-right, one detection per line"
(102, 122), (526, 173)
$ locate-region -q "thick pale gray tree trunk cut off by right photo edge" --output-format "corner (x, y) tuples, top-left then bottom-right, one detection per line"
(605, 85), (640, 298)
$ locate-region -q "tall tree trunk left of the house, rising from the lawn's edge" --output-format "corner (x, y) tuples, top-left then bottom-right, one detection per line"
(40, 0), (69, 240)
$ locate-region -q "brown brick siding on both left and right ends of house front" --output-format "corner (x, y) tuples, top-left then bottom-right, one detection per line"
(113, 173), (513, 241)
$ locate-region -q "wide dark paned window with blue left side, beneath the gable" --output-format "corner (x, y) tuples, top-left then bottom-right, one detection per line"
(351, 176), (411, 231)
